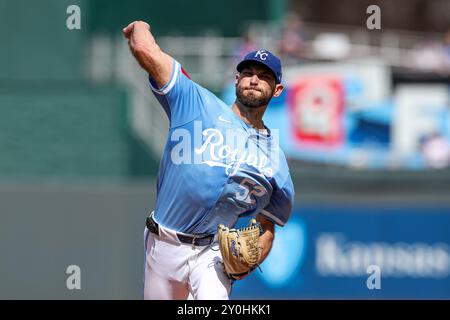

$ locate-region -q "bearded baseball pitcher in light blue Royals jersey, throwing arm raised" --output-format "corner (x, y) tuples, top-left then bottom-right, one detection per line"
(123, 21), (294, 300)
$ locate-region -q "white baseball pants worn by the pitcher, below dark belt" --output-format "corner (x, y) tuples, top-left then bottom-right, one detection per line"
(144, 225), (231, 300)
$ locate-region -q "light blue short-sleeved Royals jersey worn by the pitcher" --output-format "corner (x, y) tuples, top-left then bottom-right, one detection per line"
(150, 60), (294, 234)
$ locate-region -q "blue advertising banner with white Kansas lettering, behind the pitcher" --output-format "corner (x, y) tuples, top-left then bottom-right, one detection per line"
(232, 204), (450, 299)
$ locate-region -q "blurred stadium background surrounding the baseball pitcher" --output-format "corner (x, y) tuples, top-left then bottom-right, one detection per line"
(0, 0), (450, 299)
